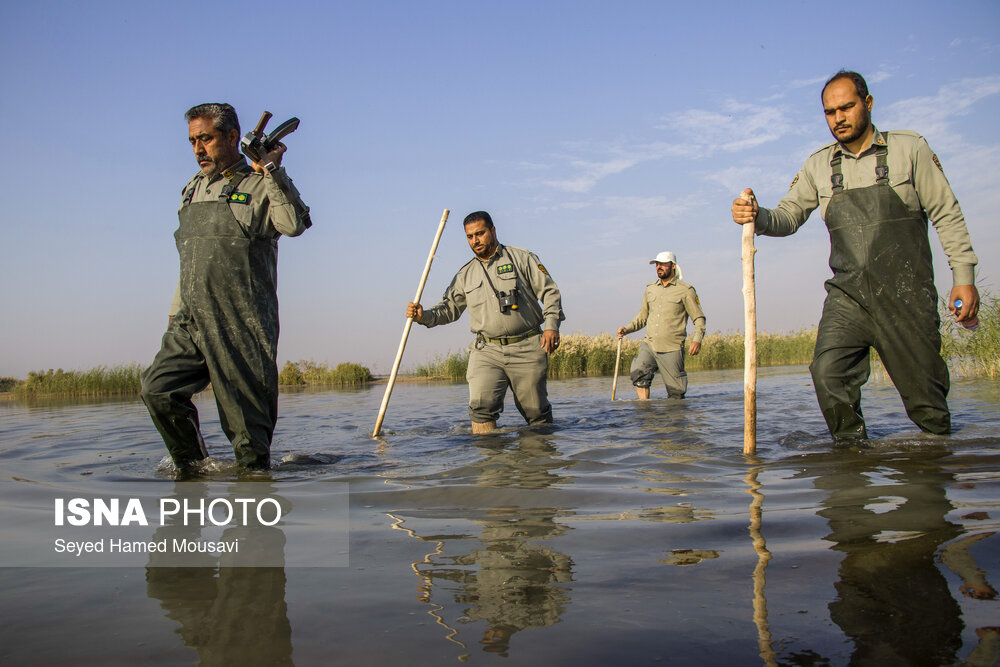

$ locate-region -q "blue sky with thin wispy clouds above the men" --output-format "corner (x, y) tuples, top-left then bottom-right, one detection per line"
(0, 0), (1000, 377)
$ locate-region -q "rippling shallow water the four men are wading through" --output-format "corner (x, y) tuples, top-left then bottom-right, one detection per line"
(0, 367), (1000, 665)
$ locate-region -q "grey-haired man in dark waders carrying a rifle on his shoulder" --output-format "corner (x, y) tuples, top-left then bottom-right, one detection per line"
(142, 103), (311, 468)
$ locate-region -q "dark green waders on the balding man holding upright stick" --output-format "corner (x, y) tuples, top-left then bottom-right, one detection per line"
(809, 140), (951, 441)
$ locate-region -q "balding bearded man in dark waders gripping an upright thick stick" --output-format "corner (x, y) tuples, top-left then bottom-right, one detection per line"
(732, 70), (979, 442)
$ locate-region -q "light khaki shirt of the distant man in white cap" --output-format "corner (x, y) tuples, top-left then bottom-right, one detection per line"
(625, 276), (705, 352)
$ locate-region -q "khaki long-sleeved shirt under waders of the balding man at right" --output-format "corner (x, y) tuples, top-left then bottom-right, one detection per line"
(756, 130), (979, 285)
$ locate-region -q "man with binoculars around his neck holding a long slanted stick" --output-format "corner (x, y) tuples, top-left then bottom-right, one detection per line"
(406, 211), (566, 433)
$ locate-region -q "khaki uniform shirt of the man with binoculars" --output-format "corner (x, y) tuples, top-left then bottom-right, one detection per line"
(420, 245), (566, 338)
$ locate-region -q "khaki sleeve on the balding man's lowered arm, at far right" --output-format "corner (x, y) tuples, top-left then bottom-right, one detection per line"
(913, 137), (979, 285)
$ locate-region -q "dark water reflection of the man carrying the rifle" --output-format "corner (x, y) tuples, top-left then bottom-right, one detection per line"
(146, 483), (293, 665)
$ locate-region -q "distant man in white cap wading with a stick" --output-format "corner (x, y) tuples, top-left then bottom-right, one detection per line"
(618, 251), (705, 399)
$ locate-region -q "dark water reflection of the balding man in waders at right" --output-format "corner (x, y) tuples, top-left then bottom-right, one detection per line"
(816, 452), (963, 665)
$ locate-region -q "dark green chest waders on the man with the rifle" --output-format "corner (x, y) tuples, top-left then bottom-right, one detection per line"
(142, 172), (278, 468)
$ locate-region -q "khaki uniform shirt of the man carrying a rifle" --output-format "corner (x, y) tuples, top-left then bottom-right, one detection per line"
(170, 159), (309, 317)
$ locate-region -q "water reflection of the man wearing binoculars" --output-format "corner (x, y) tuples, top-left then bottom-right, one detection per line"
(389, 430), (573, 656)
